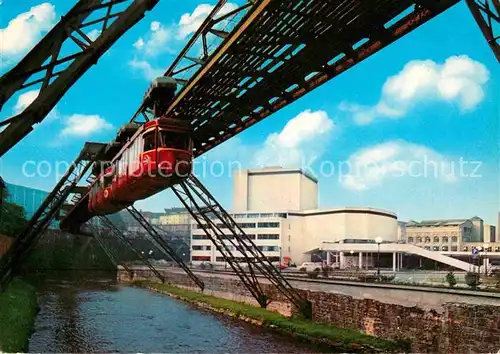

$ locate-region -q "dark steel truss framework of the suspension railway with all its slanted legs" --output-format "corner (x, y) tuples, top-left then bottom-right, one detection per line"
(0, 0), (500, 314)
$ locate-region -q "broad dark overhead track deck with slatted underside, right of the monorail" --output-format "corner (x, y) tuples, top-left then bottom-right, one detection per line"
(151, 0), (459, 156)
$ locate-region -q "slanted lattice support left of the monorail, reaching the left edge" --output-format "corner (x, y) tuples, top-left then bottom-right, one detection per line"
(0, 143), (105, 289)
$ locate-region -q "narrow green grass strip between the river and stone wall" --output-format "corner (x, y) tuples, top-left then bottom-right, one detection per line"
(133, 281), (410, 352)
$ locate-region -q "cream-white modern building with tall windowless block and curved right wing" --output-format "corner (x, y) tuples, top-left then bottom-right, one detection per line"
(191, 168), (398, 264)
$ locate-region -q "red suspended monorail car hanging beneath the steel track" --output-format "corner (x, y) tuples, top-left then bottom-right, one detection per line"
(88, 77), (193, 215)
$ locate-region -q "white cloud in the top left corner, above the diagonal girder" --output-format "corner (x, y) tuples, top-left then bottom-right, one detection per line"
(0, 2), (56, 58)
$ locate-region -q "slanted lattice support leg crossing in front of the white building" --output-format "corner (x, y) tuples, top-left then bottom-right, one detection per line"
(172, 175), (312, 318)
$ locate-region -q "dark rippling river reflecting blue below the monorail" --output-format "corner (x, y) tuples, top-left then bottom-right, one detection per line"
(29, 277), (316, 353)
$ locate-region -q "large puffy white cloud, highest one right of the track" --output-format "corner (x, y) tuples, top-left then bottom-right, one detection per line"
(339, 55), (490, 125)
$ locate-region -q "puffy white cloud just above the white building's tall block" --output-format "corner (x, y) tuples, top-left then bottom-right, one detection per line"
(254, 110), (334, 167)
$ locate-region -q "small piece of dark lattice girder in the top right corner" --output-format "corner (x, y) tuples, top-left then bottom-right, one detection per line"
(466, 0), (500, 62)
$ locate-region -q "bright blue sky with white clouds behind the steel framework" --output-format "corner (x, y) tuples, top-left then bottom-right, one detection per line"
(0, 0), (500, 224)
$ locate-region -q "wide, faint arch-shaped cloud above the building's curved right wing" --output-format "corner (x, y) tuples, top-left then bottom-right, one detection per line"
(339, 140), (459, 190)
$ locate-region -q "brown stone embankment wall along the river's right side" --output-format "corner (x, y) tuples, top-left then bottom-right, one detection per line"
(118, 268), (500, 353)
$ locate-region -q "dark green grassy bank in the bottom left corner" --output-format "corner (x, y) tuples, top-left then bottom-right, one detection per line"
(0, 279), (37, 353)
